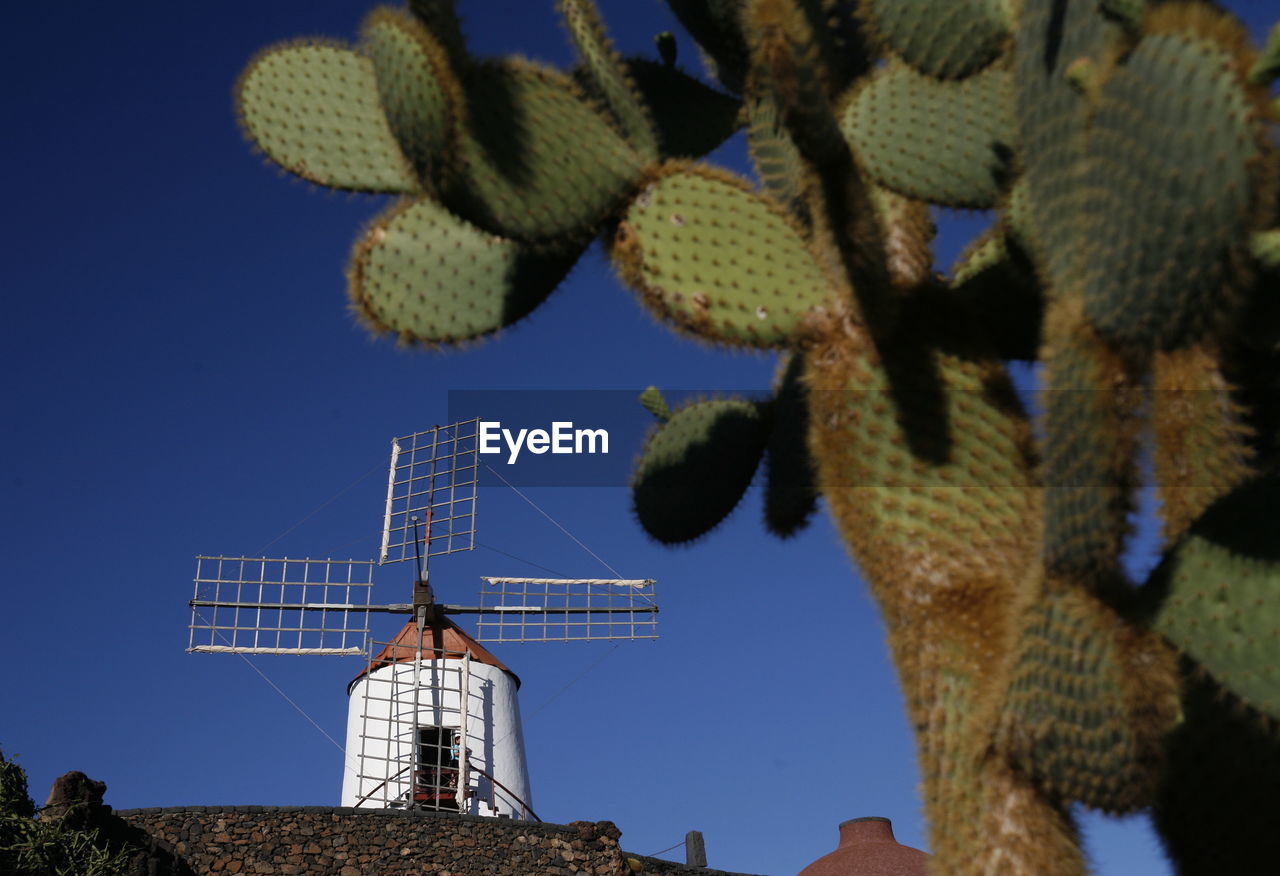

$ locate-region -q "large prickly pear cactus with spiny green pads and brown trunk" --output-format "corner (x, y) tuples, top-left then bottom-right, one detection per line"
(237, 0), (1280, 875)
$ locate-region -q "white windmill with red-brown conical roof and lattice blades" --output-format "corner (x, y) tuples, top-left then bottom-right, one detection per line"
(187, 419), (658, 818)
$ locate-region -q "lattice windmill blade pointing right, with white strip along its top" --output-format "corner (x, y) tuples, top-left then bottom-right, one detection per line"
(476, 576), (658, 642)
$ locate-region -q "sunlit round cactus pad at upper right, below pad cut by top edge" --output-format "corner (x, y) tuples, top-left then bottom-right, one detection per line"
(841, 65), (1018, 209)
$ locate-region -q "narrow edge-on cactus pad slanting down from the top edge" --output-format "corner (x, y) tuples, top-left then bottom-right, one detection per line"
(557, 0), (658, 161)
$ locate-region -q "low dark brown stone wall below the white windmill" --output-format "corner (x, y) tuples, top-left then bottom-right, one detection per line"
(115, 806), (757, 876)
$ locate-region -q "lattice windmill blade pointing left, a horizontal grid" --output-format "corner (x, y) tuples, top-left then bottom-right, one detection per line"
(187, 556), (376, 656)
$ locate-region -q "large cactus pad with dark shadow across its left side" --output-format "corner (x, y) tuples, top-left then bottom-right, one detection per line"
(442, 61), (641, 242)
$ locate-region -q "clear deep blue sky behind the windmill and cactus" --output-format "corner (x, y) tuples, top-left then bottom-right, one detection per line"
(0, 0), (1276, 876)
